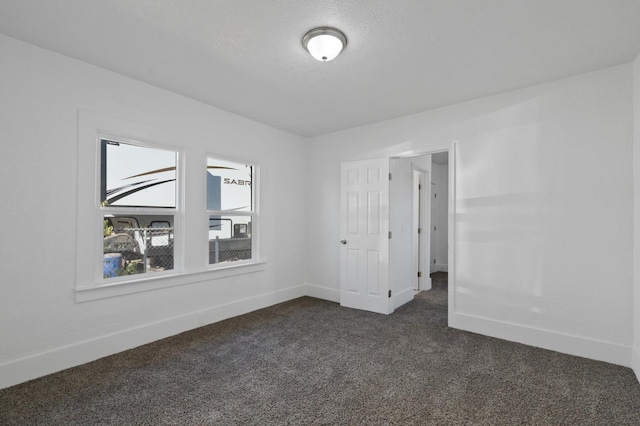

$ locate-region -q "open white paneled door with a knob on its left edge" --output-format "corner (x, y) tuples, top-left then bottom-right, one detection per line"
(340, 158), (392, 314)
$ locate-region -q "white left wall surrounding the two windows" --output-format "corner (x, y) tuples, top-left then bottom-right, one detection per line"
(0, 36), (307, 387)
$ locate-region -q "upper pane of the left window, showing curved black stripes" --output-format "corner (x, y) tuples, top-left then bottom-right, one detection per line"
(100, 139), (177, 208)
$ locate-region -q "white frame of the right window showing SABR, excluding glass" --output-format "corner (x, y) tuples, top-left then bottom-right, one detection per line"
(204, 152), (260, 270)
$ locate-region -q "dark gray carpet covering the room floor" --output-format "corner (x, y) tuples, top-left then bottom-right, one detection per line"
(0, 280), (640, 425)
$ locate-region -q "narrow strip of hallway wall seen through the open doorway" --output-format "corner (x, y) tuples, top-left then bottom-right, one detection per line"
(429, 163), (449, 272)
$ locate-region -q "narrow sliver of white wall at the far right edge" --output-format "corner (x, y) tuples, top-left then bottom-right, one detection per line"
(633, 51), (640, 380)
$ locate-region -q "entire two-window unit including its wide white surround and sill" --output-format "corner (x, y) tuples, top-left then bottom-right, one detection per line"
(75, 110), (266, 302)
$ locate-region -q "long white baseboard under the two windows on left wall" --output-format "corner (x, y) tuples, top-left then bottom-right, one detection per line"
(0, 285), (305, 389)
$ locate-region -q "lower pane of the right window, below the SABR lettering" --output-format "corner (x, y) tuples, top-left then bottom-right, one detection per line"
(209, 215), (251, 264)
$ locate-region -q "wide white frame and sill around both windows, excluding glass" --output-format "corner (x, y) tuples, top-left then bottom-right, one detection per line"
(75, 110), (266, 303)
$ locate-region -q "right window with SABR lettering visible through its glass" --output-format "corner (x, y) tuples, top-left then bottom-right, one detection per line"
(206, 157), (256, 265)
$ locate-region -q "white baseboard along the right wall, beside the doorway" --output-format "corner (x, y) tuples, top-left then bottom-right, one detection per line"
(449, 312), (640, 368)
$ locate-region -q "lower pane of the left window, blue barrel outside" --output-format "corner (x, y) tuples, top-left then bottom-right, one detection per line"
(103, 215), (174, 278)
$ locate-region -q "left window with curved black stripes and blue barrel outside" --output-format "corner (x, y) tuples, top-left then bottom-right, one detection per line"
(99, 138), (179, 280)
